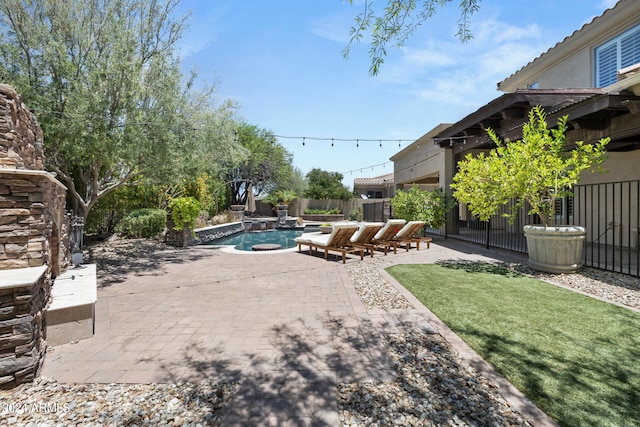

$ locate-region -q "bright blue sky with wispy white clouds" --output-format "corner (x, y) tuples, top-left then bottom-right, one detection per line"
(180, 0), (616, 188)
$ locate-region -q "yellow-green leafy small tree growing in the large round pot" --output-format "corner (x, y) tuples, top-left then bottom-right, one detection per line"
(451, 106), (609, 272)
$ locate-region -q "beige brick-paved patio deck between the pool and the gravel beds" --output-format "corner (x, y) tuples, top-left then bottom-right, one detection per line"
(41, 239), (553, 426)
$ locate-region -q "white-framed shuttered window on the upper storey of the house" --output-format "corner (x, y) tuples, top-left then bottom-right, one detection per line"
(595, 24), (640, 87)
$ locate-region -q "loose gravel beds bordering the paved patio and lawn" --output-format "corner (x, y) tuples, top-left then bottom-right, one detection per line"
(0, 239), (640, 426)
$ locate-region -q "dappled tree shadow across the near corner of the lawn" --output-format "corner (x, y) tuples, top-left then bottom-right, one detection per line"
(457, 327), (640, 425)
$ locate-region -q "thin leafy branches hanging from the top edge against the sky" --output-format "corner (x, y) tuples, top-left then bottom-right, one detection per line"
(343, 0), (480, 76)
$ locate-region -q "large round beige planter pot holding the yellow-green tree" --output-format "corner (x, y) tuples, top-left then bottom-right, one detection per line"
(524, 225), (586, 273)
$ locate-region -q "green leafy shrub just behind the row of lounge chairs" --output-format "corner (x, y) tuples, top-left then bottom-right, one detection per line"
(390, 186), (457, 227)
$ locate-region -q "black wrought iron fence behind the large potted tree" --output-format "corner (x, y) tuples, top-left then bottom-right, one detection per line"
(427, 181), (640, 276)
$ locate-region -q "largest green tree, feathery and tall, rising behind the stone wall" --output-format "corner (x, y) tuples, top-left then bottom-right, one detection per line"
(0, 0), (239, 218)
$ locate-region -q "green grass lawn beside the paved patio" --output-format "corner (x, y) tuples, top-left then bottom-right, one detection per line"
(388, 263), (640, 426)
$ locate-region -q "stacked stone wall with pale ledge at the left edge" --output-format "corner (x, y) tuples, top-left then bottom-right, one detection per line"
(0, 84), (70, 388)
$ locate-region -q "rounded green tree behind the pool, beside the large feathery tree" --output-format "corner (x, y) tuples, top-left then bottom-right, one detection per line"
(224, 123), (294, 204)
